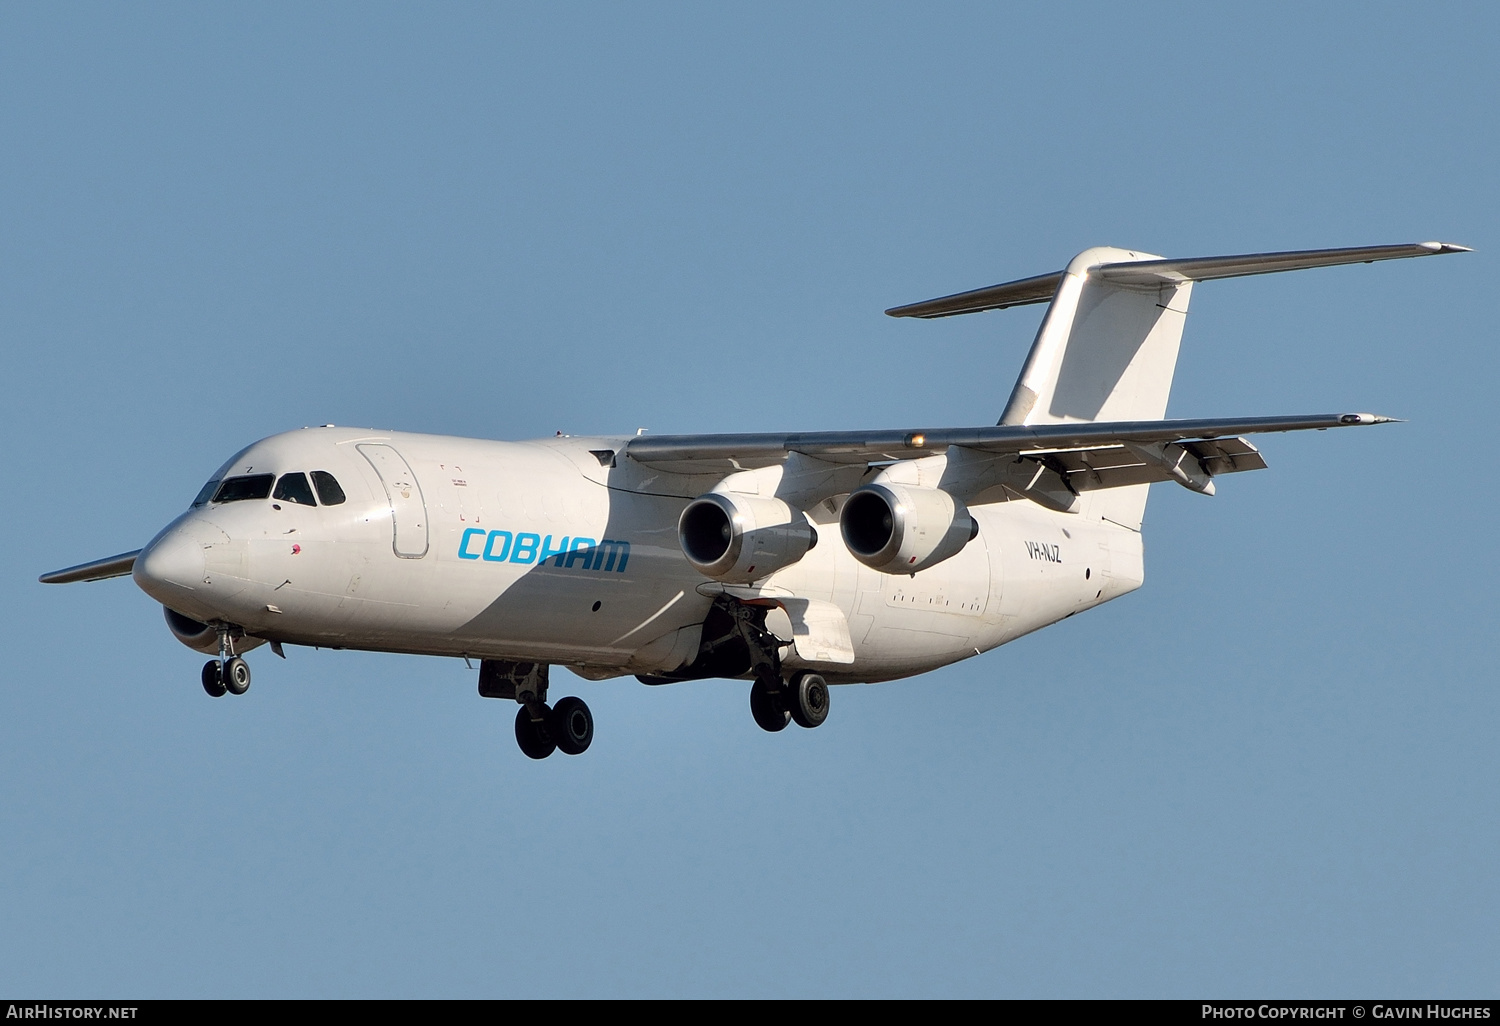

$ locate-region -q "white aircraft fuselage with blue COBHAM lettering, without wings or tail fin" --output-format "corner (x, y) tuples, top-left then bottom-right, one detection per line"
(134, 428), (1142, 683)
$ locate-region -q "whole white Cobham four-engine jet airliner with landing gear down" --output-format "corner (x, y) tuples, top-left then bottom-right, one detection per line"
(42, 243), (1466, 759)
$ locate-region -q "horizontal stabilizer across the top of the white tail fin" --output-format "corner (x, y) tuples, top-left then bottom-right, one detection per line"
(887, 242), (1470, 318)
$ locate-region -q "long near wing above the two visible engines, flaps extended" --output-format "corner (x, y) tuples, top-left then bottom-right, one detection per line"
(624, 413), (1395, 474)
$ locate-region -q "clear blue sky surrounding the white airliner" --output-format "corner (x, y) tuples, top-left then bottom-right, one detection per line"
(0, 3), (1500, 996)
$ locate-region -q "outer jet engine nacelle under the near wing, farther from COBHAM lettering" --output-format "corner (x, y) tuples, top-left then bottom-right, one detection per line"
(839, 483), (980, 573)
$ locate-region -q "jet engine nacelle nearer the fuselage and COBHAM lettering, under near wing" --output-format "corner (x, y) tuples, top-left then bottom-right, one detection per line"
(677, 492), (818, 584)
